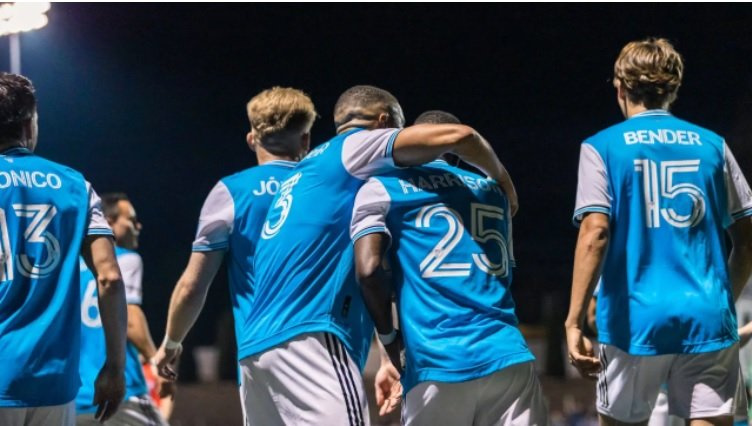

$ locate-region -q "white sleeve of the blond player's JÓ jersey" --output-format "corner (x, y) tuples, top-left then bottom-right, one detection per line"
(193, 181), (235, 251)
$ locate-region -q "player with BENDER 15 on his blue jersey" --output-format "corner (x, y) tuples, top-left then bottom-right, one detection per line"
(565, 38), (752, 425)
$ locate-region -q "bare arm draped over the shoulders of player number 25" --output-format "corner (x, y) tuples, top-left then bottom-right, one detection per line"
(392, 124), (518, 215)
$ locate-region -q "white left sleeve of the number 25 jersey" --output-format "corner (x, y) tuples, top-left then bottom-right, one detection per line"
(350, 179), (392, 242)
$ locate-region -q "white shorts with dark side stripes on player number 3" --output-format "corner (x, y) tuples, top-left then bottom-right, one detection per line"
(240, 333), (370, 426)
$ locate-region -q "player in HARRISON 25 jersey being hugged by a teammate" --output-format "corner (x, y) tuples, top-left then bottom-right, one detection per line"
(350, 111), (548, 425)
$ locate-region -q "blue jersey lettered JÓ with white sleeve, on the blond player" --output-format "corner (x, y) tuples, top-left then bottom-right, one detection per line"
(193, 160), (297, 359)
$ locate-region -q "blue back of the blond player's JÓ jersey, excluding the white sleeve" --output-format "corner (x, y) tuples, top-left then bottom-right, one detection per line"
(207, 160), (297, 358)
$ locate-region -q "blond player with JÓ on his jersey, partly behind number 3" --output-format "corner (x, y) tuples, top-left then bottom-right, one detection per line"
(156, 87), (316, 420)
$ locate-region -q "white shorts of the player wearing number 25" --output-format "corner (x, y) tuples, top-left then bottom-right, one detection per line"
(402, 362), (548, 426)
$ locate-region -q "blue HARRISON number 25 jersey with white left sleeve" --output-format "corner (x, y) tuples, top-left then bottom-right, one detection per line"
(350, 161), (534, 392)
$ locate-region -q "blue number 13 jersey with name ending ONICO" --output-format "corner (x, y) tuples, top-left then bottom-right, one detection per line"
(0, 148), (112, 407)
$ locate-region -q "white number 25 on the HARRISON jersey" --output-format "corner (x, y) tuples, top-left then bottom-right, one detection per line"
(415, 203), (509, 278)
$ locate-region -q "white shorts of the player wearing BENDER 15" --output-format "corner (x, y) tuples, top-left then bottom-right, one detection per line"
(596, 345), (747, 423)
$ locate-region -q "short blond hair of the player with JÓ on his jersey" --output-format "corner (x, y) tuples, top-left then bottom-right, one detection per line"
(246, 86), (316, 154)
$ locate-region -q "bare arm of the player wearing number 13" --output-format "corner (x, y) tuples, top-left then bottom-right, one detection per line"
(81, 235), (127, 421)
